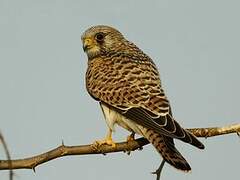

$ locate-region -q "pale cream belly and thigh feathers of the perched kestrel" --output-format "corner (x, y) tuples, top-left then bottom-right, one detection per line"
(101, 104), (142, 135)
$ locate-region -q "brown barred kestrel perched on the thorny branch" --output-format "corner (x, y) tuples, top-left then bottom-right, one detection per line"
(81, 25), (204, 172)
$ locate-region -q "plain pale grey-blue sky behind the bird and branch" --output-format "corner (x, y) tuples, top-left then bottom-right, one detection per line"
(0, 0), (240, 180)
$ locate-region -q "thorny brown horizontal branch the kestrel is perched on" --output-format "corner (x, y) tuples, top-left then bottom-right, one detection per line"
(0, 124), (240, 170)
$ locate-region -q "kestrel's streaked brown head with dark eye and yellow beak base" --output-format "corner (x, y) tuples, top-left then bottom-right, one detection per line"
(81, 25), (124, 59)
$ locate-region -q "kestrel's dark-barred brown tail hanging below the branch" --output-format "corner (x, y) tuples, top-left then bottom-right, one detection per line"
(142, 128), (191, 172)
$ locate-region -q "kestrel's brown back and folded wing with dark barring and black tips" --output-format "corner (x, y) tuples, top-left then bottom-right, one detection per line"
(86, 46), (203, 148)
